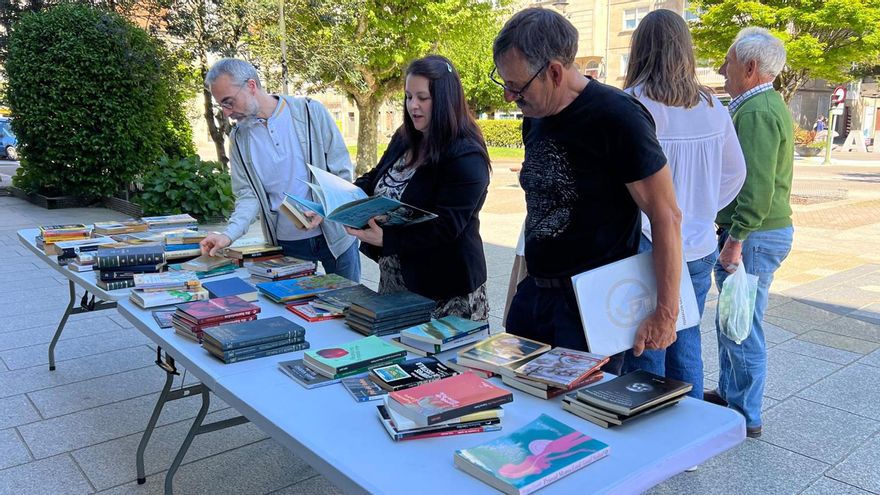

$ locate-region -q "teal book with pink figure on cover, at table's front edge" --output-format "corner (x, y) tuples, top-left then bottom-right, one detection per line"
(454, 414), (610, 495)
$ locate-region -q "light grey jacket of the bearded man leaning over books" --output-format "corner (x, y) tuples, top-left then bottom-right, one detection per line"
(223, 96), (355, 258)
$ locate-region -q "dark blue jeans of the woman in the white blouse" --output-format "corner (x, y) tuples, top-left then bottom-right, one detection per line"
(624, 236), (718, 399)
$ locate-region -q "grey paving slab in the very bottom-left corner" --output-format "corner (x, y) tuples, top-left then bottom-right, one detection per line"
(0, 454), (94, 495)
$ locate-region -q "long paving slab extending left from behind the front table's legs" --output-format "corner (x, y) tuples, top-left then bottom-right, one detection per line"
(18, 394), (229, 459)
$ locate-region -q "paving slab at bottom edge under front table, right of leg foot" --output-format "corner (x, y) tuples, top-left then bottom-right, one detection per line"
(93, 439), (317, 495)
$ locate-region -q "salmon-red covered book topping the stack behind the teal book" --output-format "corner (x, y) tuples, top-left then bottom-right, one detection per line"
(388, 372), (513, 426)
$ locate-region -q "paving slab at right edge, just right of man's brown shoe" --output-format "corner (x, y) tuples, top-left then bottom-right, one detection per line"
(761, 397), (880, 465)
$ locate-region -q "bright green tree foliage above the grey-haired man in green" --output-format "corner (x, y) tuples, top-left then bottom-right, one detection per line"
(692, 0), (880, 101)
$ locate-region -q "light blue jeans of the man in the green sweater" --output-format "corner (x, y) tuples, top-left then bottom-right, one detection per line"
(715, 227), (794, 427)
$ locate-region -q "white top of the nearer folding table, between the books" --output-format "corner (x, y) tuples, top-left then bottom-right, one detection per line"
(118, 271), (745, 495)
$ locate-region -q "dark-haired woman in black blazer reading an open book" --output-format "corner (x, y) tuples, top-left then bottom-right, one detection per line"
(346, 55), (490, 320)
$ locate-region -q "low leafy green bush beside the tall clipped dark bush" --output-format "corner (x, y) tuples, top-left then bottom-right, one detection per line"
(135, 156), (234, 219)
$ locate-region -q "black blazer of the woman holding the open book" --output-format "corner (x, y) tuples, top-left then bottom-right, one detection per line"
(355, 133), (489, 300)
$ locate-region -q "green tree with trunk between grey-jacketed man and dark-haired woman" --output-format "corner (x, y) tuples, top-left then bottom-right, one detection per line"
(255, 0), (502, 172)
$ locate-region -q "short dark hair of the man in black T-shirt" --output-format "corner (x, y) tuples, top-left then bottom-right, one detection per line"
(492, 7), (578, 72)
